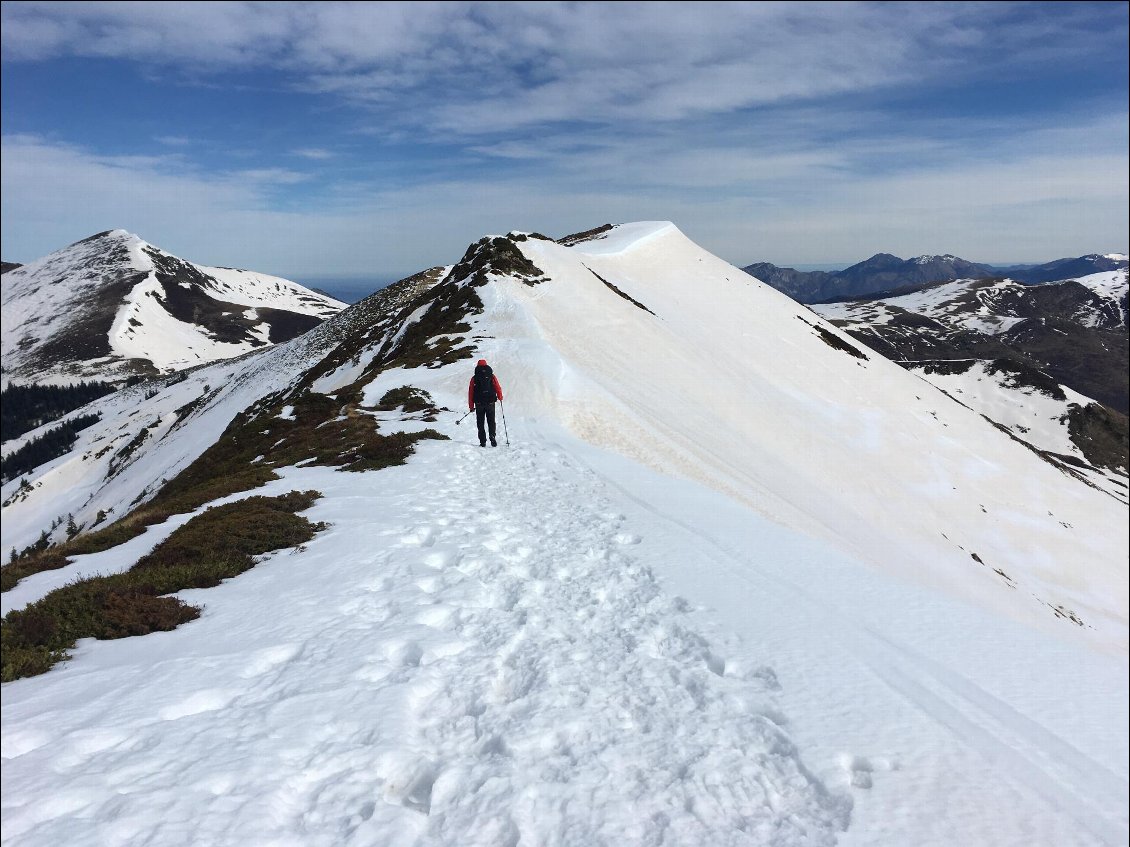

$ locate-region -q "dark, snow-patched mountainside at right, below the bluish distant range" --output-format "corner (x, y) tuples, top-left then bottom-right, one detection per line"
(811, 269), (1127, 490)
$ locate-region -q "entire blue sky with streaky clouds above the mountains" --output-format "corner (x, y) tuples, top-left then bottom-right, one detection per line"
(0, 2), (1130, 289)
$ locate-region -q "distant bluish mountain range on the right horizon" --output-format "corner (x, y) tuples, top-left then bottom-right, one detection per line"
(741, 253), (1130, 304)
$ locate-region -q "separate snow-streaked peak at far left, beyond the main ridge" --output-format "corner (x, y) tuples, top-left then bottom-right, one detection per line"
(0, 229), (345, 382)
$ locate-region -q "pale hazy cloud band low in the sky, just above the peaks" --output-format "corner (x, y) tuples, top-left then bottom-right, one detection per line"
(0, 128), (1130, 279)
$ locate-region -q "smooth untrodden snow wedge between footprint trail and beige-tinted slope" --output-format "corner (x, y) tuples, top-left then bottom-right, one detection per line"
(542, 431), (1128, 847)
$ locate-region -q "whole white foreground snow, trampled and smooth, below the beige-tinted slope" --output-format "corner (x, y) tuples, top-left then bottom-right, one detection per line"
(0, 420), (1127, 847)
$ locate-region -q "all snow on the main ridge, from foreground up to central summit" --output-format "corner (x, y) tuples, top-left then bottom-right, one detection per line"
(0, 222), (1128, 846)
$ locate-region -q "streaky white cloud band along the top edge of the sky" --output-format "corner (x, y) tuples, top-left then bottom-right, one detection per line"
(0, 2), (1124, 133)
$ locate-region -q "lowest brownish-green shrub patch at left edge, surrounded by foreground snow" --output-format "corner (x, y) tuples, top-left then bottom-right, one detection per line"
(0, 491), (324, 682)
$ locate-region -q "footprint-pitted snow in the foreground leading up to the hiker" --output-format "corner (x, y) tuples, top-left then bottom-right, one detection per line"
(3, 444), (851, 846)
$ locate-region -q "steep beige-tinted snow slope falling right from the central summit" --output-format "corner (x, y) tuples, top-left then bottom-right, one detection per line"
(484, 225), (1127, 648)
